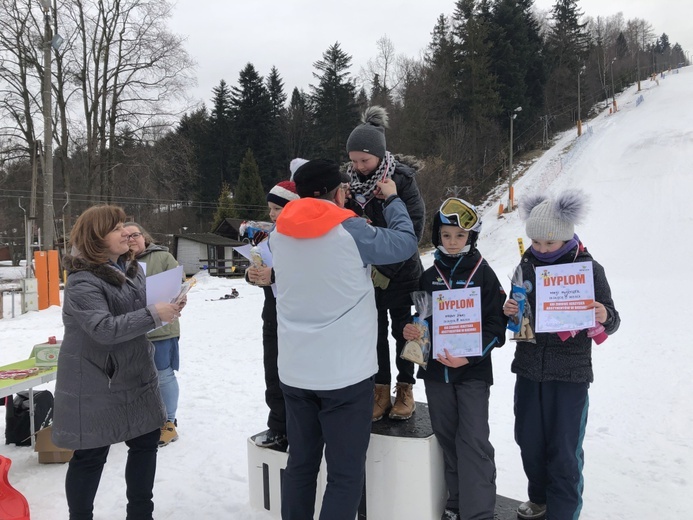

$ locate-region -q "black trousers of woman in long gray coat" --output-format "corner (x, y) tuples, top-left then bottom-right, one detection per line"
(65, 428), (161, 520)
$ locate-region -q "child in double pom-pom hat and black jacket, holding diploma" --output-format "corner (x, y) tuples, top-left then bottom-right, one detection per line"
(503, 191), (621, 520)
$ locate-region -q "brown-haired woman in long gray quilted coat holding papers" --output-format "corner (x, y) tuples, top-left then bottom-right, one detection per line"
(53, 205), (182, 520)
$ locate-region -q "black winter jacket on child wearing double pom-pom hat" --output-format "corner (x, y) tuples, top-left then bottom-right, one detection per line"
(511, 244), (621, 383)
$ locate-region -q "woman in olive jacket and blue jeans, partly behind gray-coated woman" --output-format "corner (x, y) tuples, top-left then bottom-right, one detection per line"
(125, 222), (185, 446)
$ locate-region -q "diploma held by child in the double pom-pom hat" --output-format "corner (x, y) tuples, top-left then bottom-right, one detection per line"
(536, 262), (595, 332)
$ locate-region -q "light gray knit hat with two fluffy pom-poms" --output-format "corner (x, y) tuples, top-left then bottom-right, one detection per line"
(520, 190), (587, 242)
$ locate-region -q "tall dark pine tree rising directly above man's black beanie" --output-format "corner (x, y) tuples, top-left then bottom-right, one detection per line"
(311, 42), (358, 162)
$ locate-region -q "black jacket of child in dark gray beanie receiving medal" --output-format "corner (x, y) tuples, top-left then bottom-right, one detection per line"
(346, 156), (426, 296)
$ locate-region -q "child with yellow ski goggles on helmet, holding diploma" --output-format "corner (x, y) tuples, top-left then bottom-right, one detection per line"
(404, 198), (507, 520)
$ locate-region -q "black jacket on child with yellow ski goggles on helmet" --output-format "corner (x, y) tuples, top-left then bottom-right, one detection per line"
(417, 250), (507, 385)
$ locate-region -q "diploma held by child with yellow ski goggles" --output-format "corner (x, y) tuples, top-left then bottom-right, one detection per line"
(433, 287), (482, 357)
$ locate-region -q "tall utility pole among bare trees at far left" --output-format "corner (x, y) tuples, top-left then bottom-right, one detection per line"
(40, 0), (55, 252)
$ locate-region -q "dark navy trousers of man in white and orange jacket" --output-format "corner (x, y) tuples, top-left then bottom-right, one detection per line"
(281, 377), (374, 520)
